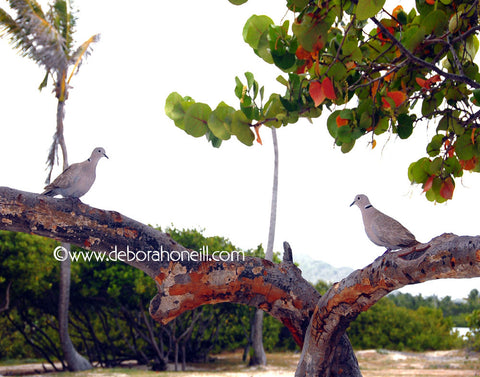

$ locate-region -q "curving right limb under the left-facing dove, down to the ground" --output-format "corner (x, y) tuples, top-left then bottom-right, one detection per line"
(296, 234), (480, 376)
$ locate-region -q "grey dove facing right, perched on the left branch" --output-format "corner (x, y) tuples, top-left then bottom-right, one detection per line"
(42, 147), (108, 198)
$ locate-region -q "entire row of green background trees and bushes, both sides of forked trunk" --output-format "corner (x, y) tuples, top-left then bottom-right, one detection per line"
(0, 227), (480, 370)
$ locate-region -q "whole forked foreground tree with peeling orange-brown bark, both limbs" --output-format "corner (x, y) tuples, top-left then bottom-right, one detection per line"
(0, 187), (480, 377)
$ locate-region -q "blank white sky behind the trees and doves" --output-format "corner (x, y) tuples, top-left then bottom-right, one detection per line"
(0, 0), (480, 297)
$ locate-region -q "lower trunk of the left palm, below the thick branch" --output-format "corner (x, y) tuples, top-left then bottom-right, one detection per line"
(58, 243), (92, 371)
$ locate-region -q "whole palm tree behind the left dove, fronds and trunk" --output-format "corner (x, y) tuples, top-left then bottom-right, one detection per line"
(0, 0), (99, 370)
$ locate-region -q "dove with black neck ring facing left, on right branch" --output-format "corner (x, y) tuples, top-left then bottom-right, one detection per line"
(350, 194), (420, 252)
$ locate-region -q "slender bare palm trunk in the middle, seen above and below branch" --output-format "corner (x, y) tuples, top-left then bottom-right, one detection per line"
(249, 127), (278, 365)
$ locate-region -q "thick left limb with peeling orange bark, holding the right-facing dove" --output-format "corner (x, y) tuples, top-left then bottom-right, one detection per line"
(0, 187), (320, 344)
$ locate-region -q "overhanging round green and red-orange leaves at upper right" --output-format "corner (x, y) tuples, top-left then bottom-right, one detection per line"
(166, 0), (480, 202)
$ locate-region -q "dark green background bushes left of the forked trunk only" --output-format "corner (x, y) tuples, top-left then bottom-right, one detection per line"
(0, 227), (296, 369)
